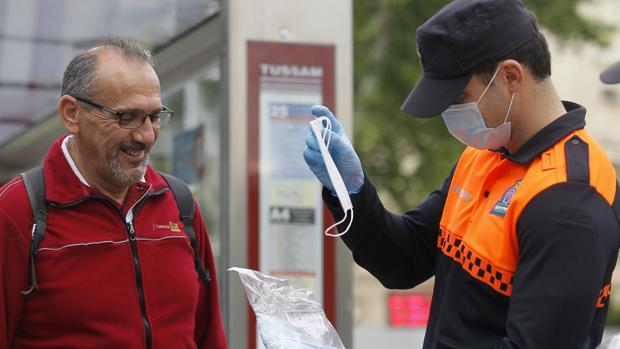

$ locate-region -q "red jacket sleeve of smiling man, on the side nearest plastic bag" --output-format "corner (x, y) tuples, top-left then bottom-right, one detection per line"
(194, 203), (228, 349)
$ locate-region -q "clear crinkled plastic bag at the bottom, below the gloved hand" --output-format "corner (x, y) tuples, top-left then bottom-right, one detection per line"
(228, 267), (345, 349)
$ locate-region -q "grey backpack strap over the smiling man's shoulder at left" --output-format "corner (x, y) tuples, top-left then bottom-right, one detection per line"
(21, 166), (47, 295)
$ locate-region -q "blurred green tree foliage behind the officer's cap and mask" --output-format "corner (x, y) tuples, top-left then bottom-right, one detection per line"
(354, 0), (611, 212)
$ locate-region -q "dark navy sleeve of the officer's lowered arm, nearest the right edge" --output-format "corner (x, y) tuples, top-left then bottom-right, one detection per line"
(498, 183), (618, 349)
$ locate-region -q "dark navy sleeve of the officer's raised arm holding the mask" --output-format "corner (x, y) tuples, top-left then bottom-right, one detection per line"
(323, 169), (454, 289)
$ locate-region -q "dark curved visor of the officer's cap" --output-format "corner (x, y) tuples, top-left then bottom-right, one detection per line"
(400, 73), (472, 118)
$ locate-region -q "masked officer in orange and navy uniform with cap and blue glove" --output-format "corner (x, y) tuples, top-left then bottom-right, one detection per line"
(304, 0), (620, 349)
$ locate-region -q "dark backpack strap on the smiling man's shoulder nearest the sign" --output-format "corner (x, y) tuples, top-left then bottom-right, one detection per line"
(159, 172), (211, 285)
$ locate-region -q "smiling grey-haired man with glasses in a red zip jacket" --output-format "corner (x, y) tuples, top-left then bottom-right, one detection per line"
(0, 39), (226, 349)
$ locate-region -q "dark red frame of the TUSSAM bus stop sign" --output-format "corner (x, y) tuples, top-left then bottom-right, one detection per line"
(246, 41), (336, 349)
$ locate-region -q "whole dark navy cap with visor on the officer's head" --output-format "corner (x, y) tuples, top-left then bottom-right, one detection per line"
(401, 0), (538, 118)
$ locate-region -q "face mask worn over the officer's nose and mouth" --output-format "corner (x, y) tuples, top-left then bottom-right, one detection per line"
(441, 68), (515, 149)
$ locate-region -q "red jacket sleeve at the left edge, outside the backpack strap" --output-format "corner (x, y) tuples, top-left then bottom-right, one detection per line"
(0, 208), (32, 348)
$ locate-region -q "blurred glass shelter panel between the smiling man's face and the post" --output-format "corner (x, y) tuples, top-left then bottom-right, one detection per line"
(152, 64), (225, 278)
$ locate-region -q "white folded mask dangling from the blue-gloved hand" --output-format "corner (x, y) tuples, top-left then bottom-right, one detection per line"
(310, 116), (353, 237)
